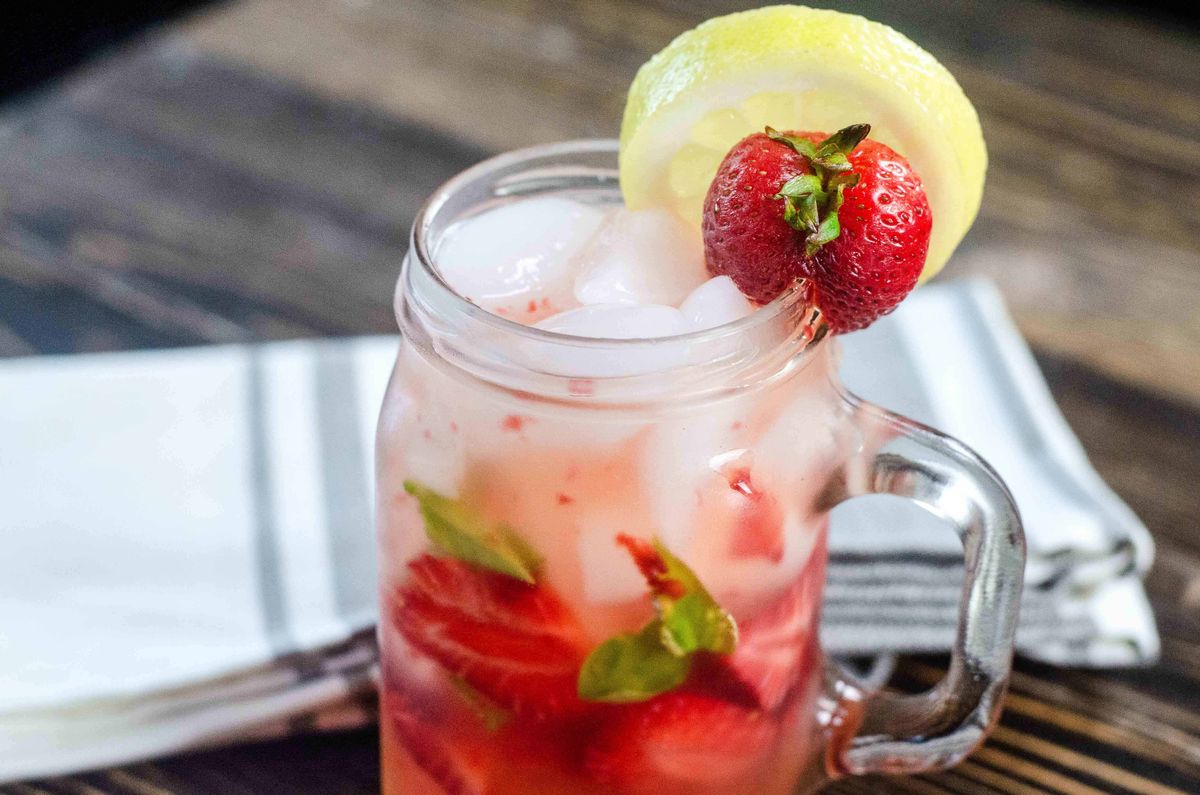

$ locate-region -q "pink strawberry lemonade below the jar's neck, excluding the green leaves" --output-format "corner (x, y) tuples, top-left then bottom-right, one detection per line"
(379, 338), (845, 794)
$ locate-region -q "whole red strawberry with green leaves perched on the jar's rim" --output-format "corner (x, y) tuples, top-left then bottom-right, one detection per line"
(703, 125), (932, 331)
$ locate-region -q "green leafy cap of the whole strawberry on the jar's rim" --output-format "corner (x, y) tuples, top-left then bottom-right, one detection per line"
(766, 124), (871, 257)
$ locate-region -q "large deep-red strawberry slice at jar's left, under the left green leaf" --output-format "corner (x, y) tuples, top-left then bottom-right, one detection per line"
(392, 555), (588, 719)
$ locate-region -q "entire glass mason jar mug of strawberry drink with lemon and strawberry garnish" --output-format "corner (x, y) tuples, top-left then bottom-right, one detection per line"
(377, 6), (1024, 795)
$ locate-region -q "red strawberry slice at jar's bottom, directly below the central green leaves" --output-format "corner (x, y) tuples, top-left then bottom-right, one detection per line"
(584, 691), (780, 795)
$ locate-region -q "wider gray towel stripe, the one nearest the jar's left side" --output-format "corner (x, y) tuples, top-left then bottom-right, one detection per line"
(313, 341), (376, 629)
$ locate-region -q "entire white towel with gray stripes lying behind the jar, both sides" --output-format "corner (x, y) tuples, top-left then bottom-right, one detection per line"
(0, 282), (1158, 782)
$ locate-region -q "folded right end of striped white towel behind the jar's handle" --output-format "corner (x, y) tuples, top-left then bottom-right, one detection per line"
(823, 280), (1158, 667)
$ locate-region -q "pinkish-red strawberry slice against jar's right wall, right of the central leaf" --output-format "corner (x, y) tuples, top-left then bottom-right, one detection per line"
(716, 534), (826, 710)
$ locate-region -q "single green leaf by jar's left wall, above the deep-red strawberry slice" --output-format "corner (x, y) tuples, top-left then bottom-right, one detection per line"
(404, 480), (541, 585)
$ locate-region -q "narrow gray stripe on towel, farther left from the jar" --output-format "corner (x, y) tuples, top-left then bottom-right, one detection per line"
(246, 353), (296, 654)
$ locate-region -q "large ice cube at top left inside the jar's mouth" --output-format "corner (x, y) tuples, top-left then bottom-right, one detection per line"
(434, 197), (605, 323)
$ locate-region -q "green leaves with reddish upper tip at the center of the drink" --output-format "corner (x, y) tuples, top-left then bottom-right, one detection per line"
(578, 534), (738, 703)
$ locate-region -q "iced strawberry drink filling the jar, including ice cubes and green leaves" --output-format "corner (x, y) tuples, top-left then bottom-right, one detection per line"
(378, 144), (888, 795)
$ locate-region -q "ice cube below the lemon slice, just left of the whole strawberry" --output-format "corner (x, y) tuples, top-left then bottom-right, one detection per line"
(575, 209), (708, 306)
